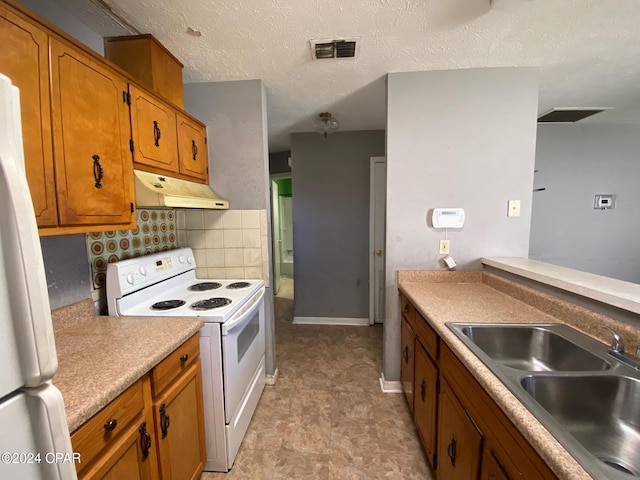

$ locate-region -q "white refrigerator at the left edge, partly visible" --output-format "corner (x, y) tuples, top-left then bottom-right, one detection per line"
(0, 74), (77, 480)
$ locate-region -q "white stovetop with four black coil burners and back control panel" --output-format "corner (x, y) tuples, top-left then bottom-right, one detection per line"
(107, 248), (264, 323)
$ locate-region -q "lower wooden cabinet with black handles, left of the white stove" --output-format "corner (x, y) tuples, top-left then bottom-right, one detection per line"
(71, 334), (206, 480)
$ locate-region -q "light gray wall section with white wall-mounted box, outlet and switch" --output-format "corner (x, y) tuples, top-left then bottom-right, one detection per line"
(383, 68), (538, 380)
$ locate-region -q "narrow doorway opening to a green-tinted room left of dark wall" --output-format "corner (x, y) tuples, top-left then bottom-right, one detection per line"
(271, 176), (294, 297)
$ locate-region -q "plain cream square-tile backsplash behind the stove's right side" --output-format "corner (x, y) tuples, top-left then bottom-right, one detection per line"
(176, 210), (269, 285)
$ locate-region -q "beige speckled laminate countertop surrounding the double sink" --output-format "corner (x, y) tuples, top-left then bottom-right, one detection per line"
(398, 272), (592, 480)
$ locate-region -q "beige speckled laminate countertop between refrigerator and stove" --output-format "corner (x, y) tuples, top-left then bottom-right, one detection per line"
(52, 300), (202, 432)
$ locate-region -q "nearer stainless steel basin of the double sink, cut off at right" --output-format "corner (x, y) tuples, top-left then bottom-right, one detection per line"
(520, 375), (640, 476)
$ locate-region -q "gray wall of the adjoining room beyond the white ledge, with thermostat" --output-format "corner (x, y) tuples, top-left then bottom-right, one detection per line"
(529, 124), (640, 283)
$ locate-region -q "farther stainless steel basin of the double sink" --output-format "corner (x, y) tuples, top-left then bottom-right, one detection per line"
(454, 324), (610, 372)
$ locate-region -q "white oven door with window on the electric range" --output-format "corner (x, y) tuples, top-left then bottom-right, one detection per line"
(222, 288), (265, 423)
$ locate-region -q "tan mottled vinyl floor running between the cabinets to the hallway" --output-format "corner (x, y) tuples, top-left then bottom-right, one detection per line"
(201, 281), (432, 480)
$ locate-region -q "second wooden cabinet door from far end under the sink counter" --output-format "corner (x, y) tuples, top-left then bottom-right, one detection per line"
(413, 341), (438, 467)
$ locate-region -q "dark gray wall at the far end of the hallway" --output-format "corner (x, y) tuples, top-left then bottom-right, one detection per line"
(291, 131), (384, 318)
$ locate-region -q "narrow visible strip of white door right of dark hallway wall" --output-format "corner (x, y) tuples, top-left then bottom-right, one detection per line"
(369, 157), (387, 325)
